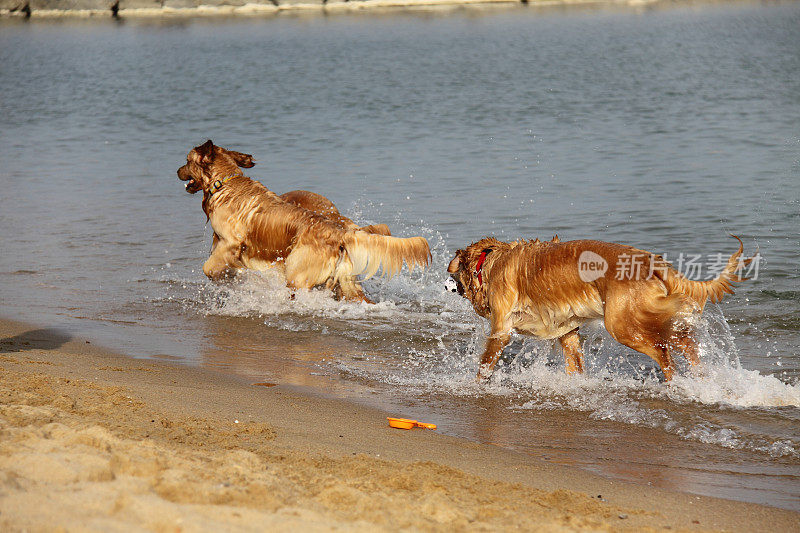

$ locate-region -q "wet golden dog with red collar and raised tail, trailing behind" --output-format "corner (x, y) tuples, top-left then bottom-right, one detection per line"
(447, 236), (753, 381)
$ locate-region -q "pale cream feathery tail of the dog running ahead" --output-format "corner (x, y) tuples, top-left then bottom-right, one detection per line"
(344, 231), (431, 279)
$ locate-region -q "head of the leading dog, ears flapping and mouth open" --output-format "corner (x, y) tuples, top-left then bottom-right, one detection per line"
(178, 140), (255, 194)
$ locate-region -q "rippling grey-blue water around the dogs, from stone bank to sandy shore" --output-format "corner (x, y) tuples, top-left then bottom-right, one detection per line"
(0, 3), (800, 509)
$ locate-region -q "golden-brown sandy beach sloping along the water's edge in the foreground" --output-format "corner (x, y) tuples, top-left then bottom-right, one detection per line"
(0, 314), (800, 531)
